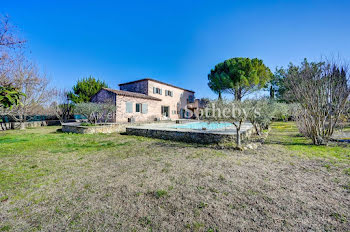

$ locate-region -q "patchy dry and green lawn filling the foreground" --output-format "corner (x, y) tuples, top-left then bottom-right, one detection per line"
(0, 123), (350, 231)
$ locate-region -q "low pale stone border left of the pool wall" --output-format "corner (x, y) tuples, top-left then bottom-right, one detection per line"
(62, 123), (126, 134)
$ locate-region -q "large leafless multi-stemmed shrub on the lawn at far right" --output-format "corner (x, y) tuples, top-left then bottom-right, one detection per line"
(286, 59), (350, 145)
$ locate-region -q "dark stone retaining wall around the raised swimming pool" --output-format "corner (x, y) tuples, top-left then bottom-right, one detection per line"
(126, 127), (254, 144)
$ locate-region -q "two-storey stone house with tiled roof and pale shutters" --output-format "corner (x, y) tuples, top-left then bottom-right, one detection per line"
(91, 78), (199, 122)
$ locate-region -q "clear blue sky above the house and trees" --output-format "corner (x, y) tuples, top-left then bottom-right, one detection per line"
(0, 0), (350, 98)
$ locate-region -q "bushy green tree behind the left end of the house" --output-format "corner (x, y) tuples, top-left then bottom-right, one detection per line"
(67, 76), (108, 103)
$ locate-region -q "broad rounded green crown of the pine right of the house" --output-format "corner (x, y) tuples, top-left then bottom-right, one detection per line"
(208, 57), (273, 101)
